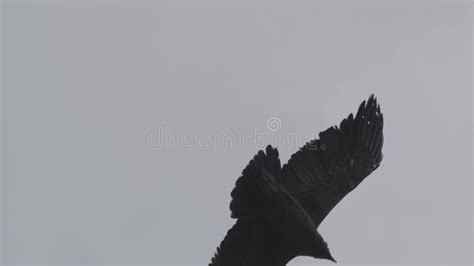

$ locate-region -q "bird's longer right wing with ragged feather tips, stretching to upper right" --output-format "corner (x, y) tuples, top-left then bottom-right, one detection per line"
(281, 95), (383, 226)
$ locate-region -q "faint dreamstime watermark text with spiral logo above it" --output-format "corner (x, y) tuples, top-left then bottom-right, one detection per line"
(147, 117), (326, 151)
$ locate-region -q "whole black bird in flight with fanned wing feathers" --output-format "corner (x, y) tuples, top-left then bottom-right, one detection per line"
(209, 94), (384, 266)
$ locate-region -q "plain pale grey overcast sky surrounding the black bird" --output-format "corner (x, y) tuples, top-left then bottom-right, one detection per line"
(1, 1), (473, 265)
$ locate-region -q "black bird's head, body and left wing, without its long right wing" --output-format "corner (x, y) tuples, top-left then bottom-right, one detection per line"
(210, 145), (334, 266)
